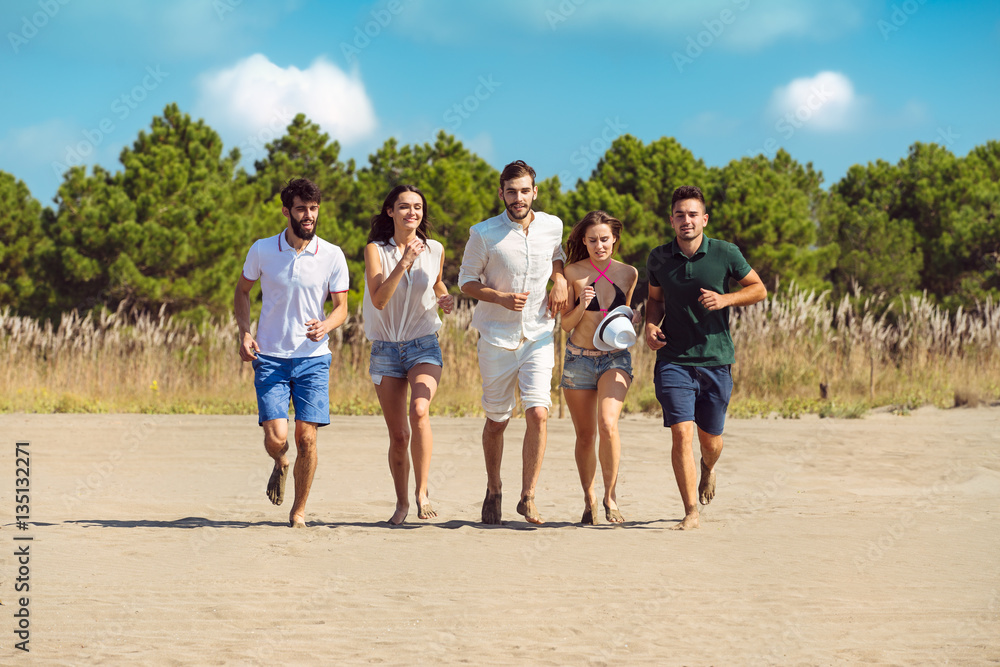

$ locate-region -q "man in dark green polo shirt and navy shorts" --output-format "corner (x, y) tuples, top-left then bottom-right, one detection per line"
(646, 185), (767, 530)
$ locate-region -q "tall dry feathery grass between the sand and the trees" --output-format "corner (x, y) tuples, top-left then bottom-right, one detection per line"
(0, 288), (1000, 416)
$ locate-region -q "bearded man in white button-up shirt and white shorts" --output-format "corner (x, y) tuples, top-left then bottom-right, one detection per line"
(458, 160), (566, 524)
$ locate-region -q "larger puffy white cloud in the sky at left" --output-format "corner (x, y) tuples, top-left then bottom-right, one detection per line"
(195, 53), (377, 144)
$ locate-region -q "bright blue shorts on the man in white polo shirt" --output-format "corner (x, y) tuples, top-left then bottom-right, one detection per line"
(251, 354), (331, 426)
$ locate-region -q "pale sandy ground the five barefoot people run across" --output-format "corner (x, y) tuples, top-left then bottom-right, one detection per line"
(0, 407), (1000, 665)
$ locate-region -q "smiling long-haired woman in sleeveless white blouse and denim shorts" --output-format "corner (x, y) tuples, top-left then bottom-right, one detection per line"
(363, 185), (454, 526)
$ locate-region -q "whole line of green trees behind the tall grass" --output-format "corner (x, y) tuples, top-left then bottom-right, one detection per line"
(0, 104), (1000, 322)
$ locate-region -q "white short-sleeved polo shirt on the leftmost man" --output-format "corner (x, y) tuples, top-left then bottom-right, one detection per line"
(243, 230), (349, 359)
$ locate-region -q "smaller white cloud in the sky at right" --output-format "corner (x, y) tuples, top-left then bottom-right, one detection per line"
(769, 72), (865, 132)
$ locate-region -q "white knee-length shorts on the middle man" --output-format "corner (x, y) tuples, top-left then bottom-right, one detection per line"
(477, 333), (556, 422)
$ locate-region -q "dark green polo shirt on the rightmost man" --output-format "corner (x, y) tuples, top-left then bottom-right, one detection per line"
(646, 236), (750, 366)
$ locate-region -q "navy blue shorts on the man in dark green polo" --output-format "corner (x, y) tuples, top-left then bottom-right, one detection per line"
(653, 361), (733, 435)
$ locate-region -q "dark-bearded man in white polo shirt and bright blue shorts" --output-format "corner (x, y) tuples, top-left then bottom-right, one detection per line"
(233, 178), (348, 528)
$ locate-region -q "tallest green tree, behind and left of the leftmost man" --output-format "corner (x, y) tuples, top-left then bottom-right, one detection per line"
(49, 104), (249, 314)
